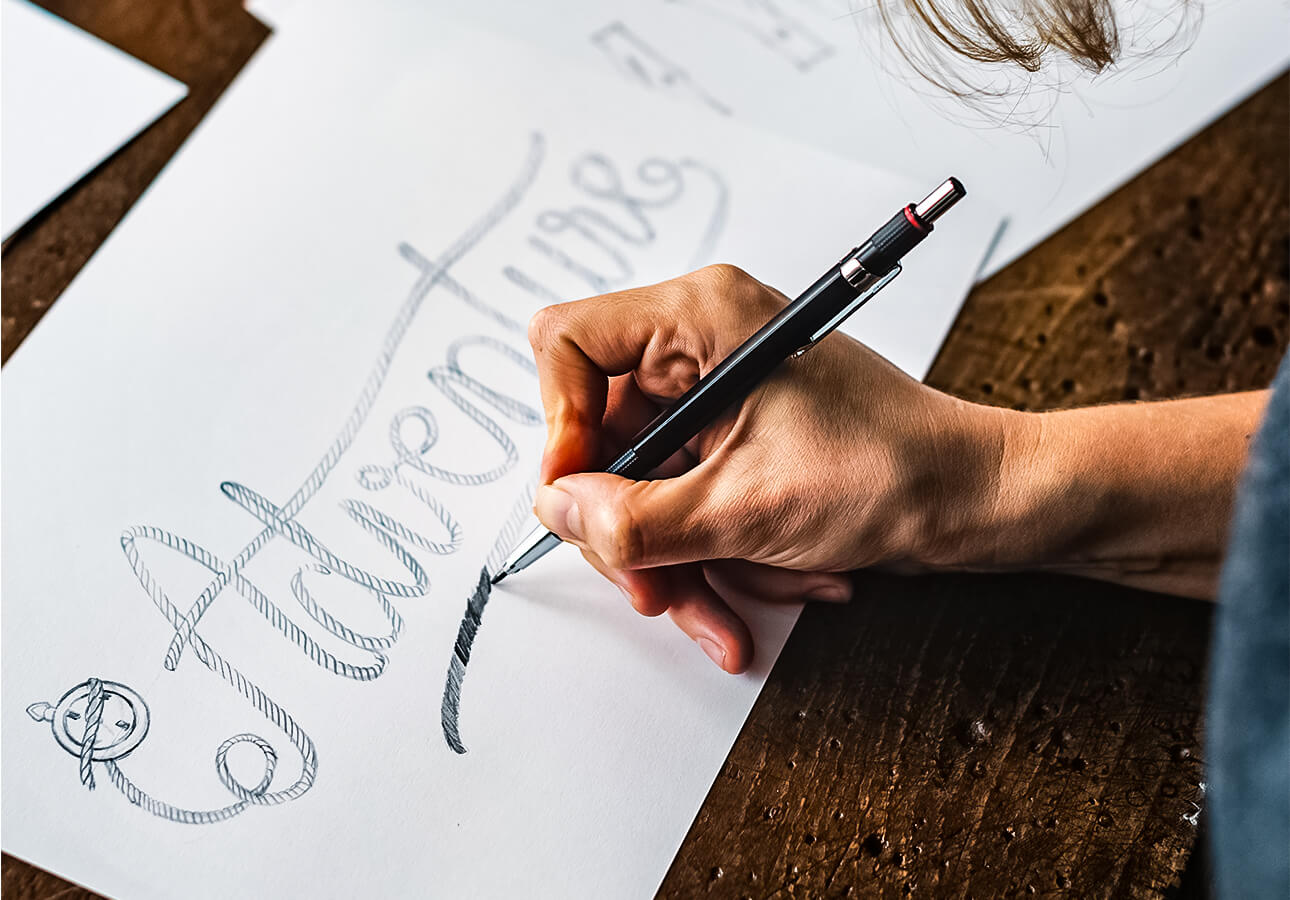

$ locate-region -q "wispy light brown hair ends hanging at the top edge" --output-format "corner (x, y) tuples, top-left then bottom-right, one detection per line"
(873, 0), (1200, 124)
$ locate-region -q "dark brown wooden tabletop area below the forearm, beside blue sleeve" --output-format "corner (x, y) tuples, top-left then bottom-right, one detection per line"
(663, 574), (1209, 897)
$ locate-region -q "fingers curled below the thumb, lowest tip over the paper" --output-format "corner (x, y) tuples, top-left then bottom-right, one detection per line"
(583, 552), (753, 674)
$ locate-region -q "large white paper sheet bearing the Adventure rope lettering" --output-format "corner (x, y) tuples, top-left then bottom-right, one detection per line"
(0, 3), (992, 897)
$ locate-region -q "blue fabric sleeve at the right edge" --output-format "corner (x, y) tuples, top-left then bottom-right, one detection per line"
(1206, 356), (1290, 900)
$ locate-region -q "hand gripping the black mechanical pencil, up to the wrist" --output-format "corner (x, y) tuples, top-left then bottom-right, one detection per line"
(529, 266), (1009, 673)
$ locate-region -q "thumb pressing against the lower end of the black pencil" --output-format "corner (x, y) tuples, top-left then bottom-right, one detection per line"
(534, 469), (738, 569)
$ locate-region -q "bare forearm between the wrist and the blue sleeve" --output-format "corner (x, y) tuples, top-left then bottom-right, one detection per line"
(940, 391), (1268, 597)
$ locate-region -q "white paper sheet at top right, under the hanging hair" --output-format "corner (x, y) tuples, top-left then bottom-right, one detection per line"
(410, 0), (1290, 275)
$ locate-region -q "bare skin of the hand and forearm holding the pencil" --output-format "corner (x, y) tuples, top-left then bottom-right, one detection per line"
(529, 266), (1268, 673)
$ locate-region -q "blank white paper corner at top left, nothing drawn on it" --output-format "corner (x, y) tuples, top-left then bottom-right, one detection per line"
(0, 0), (188, 237)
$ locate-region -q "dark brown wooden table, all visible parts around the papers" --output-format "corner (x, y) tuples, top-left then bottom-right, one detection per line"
(3, 0), (1290, 900)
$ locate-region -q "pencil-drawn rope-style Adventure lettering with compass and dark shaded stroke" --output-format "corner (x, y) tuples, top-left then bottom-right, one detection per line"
(27, 134), (728, 824)
